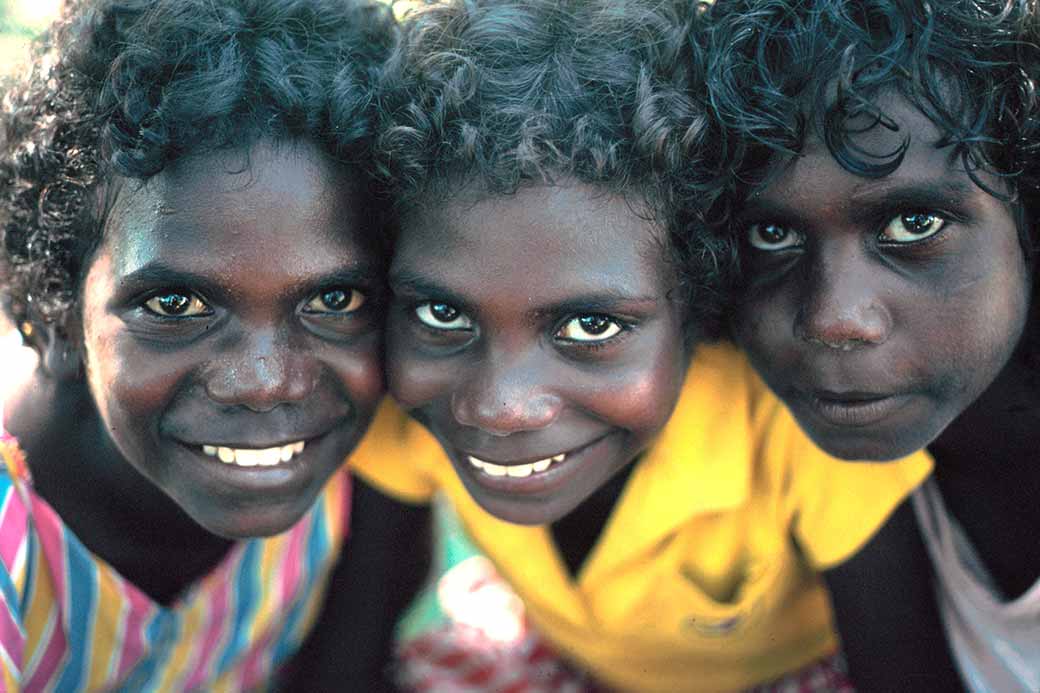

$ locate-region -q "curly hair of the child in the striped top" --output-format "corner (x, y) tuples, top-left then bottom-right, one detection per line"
(0, 0), (396, 333)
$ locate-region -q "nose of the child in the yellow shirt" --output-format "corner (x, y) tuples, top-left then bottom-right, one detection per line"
(451, 350), (563, 436)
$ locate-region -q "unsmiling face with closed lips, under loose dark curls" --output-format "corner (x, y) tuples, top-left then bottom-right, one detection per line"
(736, 91), (1032, 460)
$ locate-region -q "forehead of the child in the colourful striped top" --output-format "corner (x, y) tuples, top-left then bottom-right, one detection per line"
(102, 143), (374, 275)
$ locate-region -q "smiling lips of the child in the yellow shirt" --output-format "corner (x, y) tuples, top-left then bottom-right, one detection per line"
(452, 432), (610, 495)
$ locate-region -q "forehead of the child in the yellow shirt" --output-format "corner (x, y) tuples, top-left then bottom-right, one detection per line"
(392, 183), (670, 300)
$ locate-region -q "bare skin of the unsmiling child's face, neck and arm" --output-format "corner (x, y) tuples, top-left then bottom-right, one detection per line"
(737, 97), (1040, 691)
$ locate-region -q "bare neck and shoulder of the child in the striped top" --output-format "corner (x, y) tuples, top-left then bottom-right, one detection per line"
(6, 370), (231, 602)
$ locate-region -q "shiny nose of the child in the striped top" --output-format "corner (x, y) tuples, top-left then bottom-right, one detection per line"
(206, 329), (319, 412)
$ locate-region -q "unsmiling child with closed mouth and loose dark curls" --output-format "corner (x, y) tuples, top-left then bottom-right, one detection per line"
(709, 0), (1040, 691)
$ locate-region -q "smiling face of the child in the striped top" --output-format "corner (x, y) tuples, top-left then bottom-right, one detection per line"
(81, 144), (385, 538)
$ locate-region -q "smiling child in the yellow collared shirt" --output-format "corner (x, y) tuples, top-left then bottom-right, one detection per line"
(354, 0), (929, 692)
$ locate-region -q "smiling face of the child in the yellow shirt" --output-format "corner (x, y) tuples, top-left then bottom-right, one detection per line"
(388, 184), (686, 524)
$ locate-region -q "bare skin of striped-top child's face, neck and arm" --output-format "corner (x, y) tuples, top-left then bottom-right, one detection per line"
(6, 143), (426, 690)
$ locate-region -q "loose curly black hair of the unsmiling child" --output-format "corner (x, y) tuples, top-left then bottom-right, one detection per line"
(701, 0), (1040, 365)
